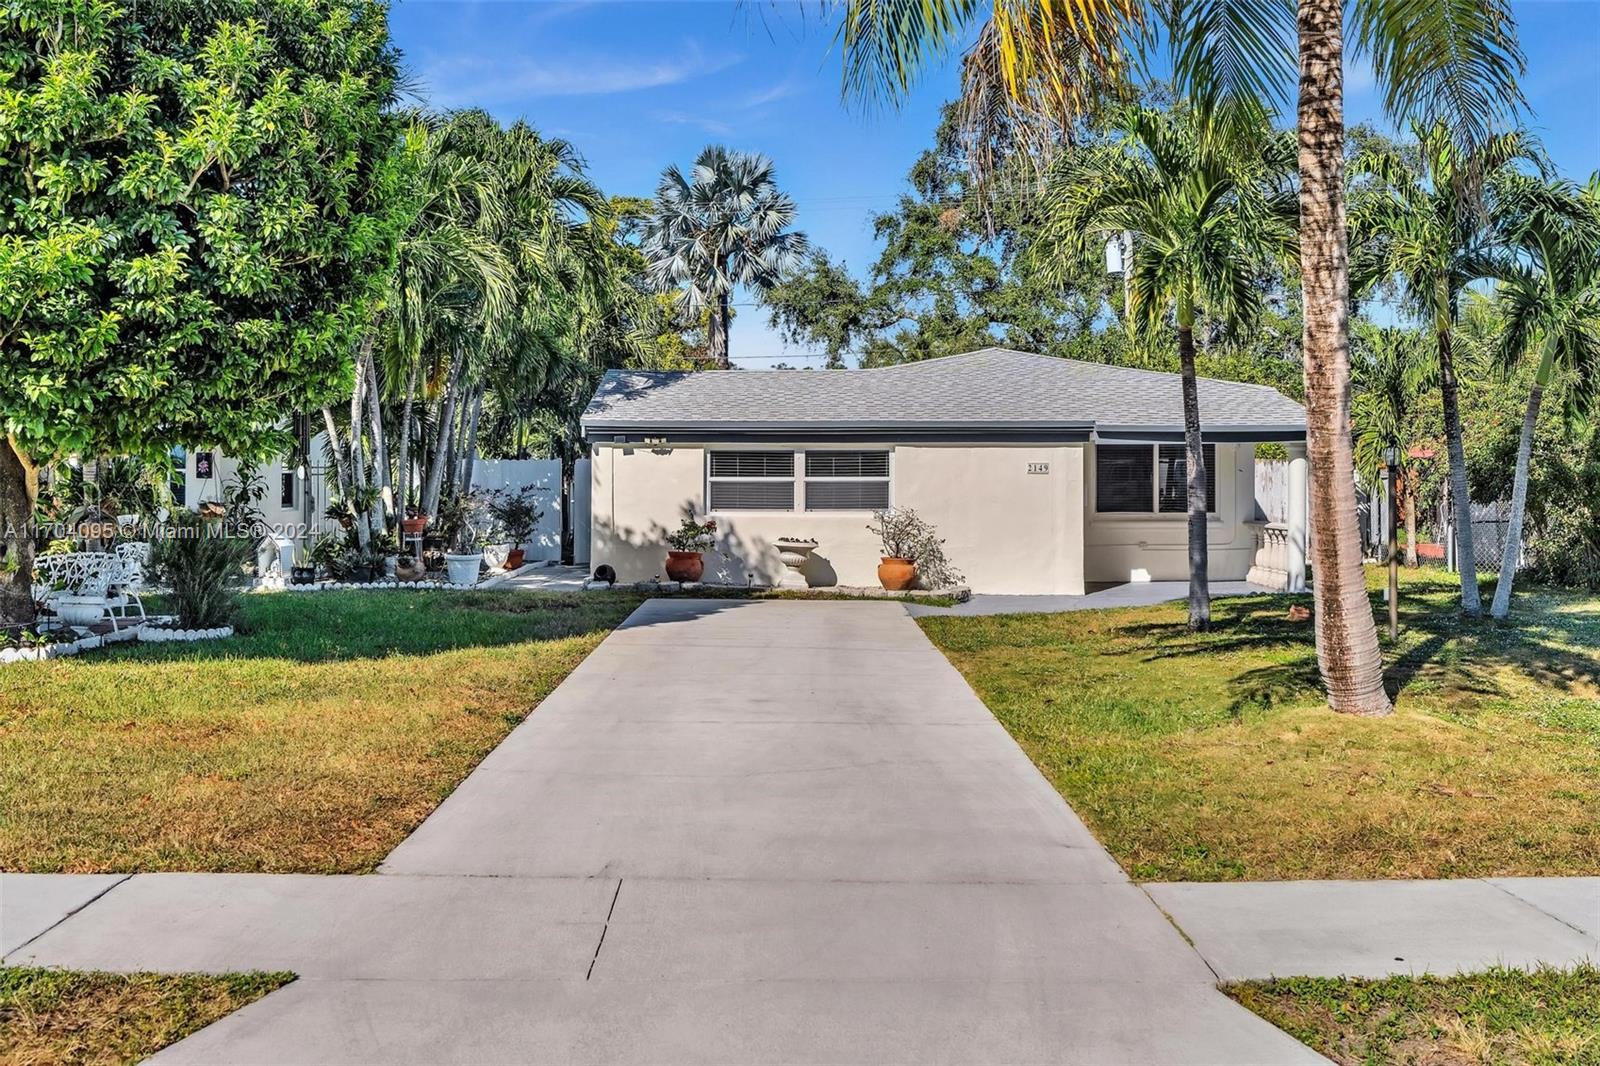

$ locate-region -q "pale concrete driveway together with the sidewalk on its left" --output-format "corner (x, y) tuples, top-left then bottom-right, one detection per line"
(12, 600), (1320, 1063)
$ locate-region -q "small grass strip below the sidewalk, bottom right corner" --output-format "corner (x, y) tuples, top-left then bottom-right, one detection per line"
(1224, 965), (1600, 1066)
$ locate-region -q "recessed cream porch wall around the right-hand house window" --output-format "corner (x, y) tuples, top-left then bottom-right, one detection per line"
(1083, 443), (1256, 584)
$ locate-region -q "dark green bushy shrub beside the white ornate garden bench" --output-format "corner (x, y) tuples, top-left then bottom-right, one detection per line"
(150, 511), (258, 629)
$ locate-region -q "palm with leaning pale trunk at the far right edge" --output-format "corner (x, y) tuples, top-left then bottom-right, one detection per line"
(1490, 171), (1600, 618)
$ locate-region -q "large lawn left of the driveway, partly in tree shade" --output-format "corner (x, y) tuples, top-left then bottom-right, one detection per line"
(0, 592), (638, 872)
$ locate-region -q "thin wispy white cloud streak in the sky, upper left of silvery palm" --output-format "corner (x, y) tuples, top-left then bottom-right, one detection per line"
(421, 42), (741, 107)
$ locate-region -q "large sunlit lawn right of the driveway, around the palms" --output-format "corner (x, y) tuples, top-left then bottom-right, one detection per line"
(922, 571), (1600, 880)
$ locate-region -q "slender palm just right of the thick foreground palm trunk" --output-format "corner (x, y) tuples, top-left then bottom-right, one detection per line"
(1350, 125), (1539, 615)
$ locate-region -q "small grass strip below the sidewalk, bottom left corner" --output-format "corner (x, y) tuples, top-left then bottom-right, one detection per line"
(0, 968), (294, 1066)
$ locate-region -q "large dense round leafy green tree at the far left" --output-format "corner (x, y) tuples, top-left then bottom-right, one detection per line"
(0, 0), (397, 619)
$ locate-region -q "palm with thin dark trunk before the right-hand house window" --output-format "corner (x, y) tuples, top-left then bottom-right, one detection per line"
(1034, 107), (1294, 631)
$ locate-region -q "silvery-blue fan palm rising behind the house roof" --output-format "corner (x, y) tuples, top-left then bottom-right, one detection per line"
(643, 144), (806, 370)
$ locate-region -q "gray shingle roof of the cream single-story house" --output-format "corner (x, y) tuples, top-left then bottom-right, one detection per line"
(582, 347), (1306, 437)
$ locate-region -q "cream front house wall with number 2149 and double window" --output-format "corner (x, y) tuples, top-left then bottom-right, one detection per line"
(589, 445), (1086, 595)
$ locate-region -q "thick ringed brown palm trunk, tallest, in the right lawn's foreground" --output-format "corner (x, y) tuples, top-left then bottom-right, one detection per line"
(1296, 0), (1394, 715)
